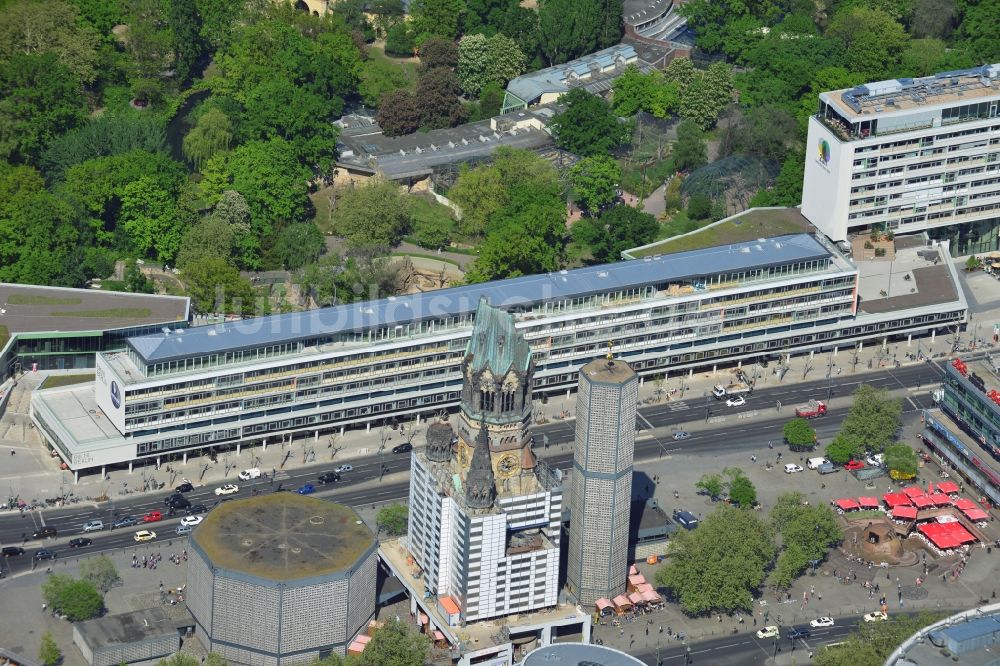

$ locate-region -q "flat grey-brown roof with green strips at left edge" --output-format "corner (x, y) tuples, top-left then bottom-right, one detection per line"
(0, 283), (190, 334)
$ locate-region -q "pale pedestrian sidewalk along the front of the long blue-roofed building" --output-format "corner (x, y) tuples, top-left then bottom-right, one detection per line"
(0, 324), (968, 501)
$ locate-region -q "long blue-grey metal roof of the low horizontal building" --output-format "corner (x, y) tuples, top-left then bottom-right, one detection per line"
(128, 233), (830, 363)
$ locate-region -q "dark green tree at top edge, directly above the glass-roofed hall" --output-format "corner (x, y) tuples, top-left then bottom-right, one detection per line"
(538, 0), (603, 65)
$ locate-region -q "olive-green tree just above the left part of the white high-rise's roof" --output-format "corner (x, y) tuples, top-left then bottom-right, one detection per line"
(826, 3), (912, 80)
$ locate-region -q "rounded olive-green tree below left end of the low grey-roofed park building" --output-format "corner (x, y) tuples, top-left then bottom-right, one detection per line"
(332, 179), (411, 247)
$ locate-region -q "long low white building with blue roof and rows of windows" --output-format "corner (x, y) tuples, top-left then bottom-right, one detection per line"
(32, 217), (966, 471)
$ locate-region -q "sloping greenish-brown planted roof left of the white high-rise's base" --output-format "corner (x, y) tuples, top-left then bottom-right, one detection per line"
(629, 208), (812, 258)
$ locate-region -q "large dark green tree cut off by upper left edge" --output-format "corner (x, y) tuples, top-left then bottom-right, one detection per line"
(0, 53), (86, 162)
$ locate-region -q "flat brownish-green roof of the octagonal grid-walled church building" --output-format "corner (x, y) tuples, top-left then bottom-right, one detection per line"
(192, 493), (375, 581)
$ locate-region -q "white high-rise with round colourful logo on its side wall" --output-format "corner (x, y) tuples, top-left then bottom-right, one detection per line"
(802, 64), (1000, 256)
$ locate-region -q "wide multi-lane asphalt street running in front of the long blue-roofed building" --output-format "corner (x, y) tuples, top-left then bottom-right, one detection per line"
(0, 359), (943, 574)
